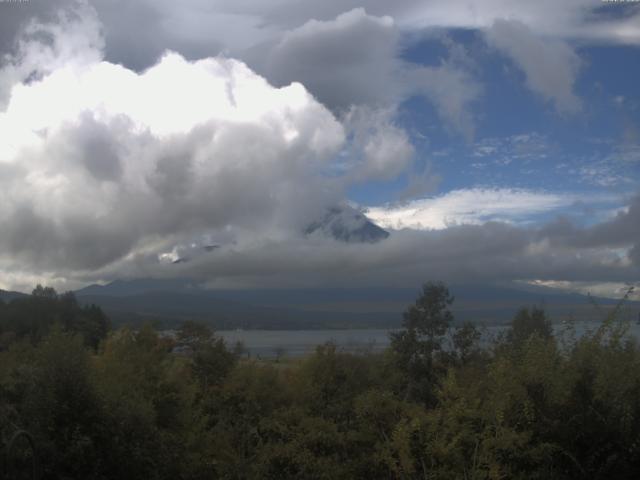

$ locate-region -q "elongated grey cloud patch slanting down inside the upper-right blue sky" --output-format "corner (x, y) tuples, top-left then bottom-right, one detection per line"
(486, 20), (582, 113)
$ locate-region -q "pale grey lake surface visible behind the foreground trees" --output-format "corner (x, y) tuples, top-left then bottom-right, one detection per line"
(216, 322), (640, 358)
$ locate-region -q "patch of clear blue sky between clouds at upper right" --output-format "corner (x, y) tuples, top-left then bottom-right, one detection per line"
(350, 30), (640, 217)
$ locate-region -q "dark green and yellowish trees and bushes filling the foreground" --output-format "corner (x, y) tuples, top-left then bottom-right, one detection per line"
(0, 284), (640, 480)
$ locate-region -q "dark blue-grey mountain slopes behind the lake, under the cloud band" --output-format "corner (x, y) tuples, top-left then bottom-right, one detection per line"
(76, 279), (640, 329)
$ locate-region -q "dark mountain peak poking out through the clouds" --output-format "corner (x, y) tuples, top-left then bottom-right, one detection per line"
(304, 205), (389, 243)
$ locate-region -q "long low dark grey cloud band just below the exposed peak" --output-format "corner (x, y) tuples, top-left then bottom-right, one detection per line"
(97, 218), (640, 287)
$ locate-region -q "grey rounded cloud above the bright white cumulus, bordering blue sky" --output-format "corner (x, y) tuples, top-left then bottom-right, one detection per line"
(265, 8), (401, 110)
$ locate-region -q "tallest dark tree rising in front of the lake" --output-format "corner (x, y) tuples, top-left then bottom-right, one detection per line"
(390, 282), (454, 404)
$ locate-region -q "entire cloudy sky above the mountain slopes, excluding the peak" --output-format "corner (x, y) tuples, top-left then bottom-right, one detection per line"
(0, 0), (640, 295)
